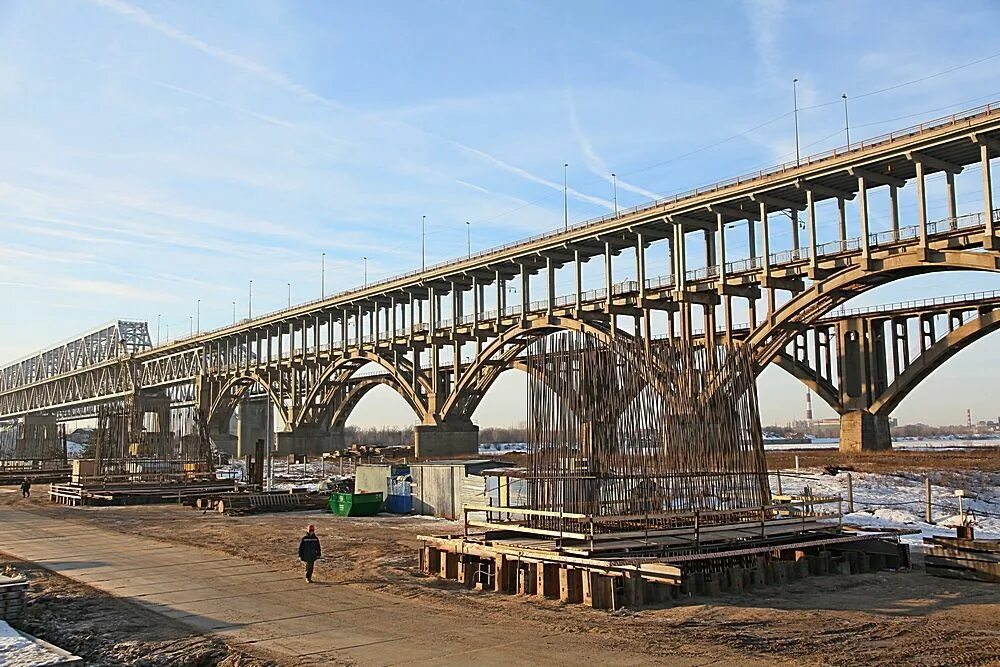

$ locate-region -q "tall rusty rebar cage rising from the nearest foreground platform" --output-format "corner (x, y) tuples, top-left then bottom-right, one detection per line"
(526, 332), (771, 531)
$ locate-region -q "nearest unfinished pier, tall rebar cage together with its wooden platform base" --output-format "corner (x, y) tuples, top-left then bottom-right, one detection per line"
(415, 332), (909, 609)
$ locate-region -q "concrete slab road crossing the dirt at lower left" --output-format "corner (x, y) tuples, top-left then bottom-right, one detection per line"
(0, 507), (672, 665)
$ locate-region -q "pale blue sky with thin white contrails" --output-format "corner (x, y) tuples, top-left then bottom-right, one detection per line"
(0, 0), (1000, 426)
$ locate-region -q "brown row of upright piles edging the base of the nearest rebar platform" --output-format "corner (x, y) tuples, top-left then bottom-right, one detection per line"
(420, 531), (909, 609)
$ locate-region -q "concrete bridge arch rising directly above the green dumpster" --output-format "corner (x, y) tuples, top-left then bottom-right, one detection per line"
(294, 352), (430, 426)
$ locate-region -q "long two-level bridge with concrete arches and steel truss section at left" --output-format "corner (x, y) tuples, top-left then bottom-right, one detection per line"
(0, 104), (1000, 456)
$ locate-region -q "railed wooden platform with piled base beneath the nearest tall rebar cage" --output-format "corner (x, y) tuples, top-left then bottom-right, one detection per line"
(420, 496), (909, 609)
